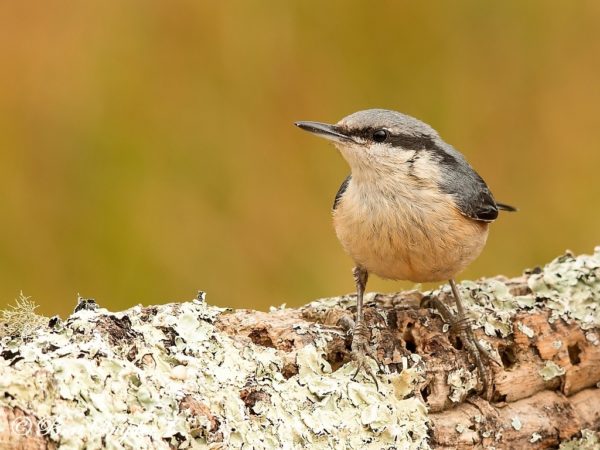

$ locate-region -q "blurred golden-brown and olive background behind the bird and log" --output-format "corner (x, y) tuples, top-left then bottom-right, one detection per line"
(0, 0), (600, 316)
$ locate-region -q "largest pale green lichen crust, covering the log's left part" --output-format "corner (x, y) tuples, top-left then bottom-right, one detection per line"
(0, 301), (429, 450)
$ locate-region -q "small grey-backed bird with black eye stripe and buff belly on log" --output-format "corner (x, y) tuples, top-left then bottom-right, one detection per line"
(295, 109), (516, 391)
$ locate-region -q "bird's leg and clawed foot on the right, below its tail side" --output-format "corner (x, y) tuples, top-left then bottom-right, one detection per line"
(446, 279), (497, 393)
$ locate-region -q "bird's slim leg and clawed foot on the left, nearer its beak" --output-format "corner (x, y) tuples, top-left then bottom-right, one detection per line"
(352, 266), (379, 390)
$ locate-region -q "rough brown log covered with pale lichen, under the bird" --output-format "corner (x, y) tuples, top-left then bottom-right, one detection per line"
(0, 249), (600, 449)
